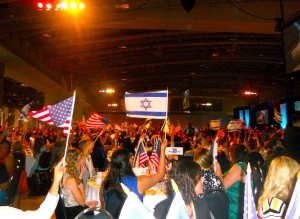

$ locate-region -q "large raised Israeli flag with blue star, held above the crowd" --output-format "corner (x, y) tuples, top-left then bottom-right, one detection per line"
(125, 90), (168, 119)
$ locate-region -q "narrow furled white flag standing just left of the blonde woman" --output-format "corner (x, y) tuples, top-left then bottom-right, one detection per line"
(243, 163), (257, 219)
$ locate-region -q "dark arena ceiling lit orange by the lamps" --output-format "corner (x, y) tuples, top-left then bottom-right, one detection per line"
(0, 0), (300, 109)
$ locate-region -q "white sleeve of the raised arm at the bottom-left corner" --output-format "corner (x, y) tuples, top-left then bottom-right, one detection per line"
(0, 193), (59, 219)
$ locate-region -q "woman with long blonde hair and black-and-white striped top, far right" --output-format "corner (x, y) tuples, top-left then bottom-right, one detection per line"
(257, 156), (300, 218)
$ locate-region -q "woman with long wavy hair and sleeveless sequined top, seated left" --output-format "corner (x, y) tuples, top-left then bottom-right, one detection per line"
(62, 148), (98, 219)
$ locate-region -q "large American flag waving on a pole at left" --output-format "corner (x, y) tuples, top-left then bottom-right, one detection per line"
(28, 96), (73, 136)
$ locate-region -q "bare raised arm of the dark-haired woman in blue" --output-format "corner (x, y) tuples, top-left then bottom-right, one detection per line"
(138, 139), (168, 194)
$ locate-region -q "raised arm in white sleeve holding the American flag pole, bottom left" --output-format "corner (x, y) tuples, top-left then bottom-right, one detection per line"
(0, 159), (65, 219)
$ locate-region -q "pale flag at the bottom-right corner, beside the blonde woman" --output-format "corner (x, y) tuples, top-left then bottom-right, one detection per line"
(285, 173), (300, 219)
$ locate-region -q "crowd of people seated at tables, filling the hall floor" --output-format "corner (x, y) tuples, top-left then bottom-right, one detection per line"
(0, 113), (300, 219)
